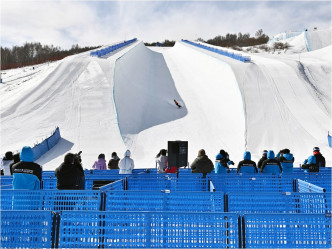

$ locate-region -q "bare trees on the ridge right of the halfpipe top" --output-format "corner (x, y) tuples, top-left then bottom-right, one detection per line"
(202, 29), (269, 47)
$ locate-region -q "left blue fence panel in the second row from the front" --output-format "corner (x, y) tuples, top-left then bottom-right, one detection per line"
(1, 189), (102, 211)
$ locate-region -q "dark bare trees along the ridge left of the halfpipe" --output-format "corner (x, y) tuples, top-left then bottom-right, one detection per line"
(1, 42), (98, 70)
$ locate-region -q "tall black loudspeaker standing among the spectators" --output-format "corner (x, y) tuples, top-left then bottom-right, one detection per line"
(168, 141), (188, 168)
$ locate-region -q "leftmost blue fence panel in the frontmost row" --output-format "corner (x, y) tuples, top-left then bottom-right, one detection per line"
(1, 210), (53, 248)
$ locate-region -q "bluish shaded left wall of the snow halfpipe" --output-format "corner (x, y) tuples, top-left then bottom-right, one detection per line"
(114, 42), (187, 147)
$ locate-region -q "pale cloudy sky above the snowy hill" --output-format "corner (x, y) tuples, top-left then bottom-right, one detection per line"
(1, 0), (331, 48)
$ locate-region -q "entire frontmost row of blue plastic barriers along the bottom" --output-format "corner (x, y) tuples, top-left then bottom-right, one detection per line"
(1, 211), (331, 248)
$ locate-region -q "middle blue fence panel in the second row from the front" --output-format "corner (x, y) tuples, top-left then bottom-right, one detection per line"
(105, 190), (224, 212)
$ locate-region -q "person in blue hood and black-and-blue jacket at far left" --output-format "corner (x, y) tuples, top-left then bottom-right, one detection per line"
(12, 146), (42, 190)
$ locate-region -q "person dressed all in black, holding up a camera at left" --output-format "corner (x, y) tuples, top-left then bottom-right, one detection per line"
(55, 153), (84, 189)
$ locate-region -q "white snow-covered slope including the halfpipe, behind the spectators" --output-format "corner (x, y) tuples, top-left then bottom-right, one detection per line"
(0, 30), (332, 170)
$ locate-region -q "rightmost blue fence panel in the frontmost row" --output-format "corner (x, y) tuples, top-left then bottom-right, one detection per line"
(243, 214), (331, 248)
